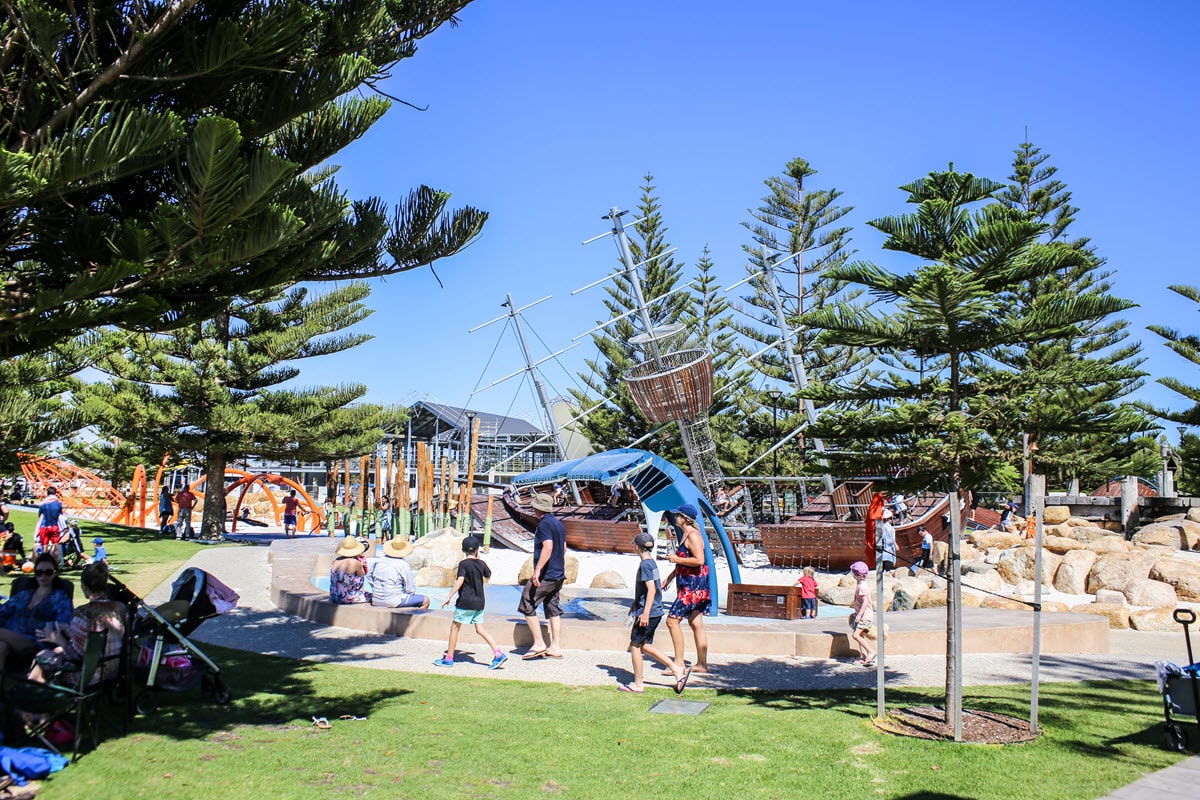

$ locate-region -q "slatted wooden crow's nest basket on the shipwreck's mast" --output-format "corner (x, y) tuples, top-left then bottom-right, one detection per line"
(625, 350), (713, 423)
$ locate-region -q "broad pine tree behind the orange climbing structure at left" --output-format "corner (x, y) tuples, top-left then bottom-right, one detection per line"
(78, 282), (397, 539)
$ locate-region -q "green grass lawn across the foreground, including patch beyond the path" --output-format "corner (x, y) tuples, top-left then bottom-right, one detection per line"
(9, 510), (1180, 800)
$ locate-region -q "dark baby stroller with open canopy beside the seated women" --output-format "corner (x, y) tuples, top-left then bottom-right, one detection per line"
(132, 567), (238, 714)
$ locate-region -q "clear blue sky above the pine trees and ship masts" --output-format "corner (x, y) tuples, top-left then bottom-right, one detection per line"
(316, 0), (1200, 439)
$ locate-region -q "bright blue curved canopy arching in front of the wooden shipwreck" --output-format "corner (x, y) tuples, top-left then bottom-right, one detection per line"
(512, 447), (742, 616)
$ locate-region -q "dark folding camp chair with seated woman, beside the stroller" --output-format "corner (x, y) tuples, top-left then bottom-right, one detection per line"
(4, 630), (108, 762)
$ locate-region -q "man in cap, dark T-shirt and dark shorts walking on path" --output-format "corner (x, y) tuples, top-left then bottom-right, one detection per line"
(517, 494), (566, 661)
